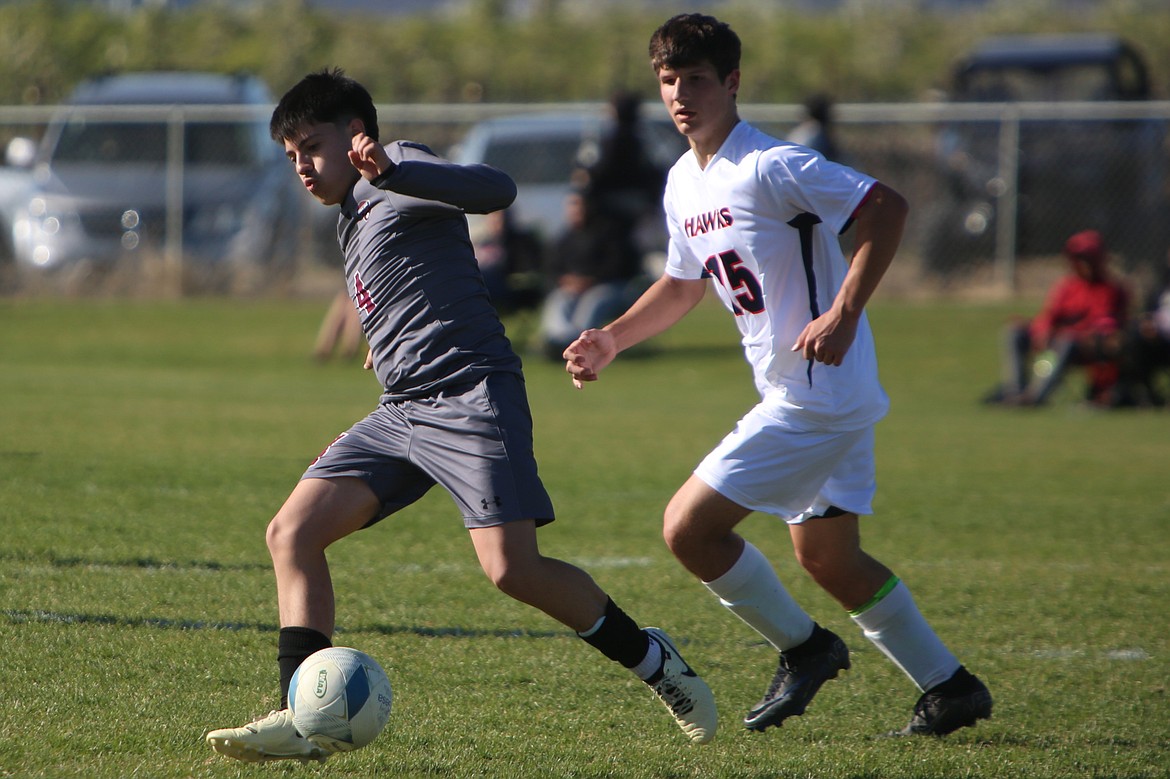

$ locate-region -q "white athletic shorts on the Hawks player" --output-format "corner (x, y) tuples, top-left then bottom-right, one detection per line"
(695, 406), (876, 524)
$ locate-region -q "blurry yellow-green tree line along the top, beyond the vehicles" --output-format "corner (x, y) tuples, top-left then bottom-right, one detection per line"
(0, 0), (1170, 105)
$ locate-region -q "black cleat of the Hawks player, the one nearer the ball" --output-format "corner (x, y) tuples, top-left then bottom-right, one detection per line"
(743, 625), (849, 732)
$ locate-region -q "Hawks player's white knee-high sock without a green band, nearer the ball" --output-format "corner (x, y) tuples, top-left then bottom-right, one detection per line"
(703, 542), (814, 652)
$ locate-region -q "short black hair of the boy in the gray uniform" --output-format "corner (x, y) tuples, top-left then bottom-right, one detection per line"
(268, 68), (378, 142)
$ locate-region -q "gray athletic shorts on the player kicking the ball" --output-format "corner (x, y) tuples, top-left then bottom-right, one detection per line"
(301, 373), (553, 528)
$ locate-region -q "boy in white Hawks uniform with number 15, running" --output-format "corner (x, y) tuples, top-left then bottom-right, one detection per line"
(564, 14), (991, 736)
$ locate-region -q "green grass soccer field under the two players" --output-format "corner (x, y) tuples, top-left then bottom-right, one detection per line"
(0, 294), (1170, 779)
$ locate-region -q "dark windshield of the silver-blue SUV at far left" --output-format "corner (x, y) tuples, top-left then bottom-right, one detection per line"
(54, 119), (256, 166)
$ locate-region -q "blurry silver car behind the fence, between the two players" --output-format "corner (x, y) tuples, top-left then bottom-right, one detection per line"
(452, 110), (688, 241)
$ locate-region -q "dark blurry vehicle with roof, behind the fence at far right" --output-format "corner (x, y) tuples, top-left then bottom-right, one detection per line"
(924, 35), (1166, 271)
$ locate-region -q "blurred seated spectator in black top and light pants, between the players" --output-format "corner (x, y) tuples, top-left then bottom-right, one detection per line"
(541, 192), (641, 360)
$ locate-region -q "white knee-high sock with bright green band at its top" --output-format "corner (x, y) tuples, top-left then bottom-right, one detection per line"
(849, 577), (959, 691)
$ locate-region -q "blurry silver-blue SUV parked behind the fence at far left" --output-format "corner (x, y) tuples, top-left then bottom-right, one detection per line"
(8, 73), (297, 284)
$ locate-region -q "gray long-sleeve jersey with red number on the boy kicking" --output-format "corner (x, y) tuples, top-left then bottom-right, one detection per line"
(337, 140), (521, 401)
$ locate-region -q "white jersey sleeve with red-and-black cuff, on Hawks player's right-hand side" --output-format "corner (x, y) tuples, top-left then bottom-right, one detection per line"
(758, 145), (876, 233)
